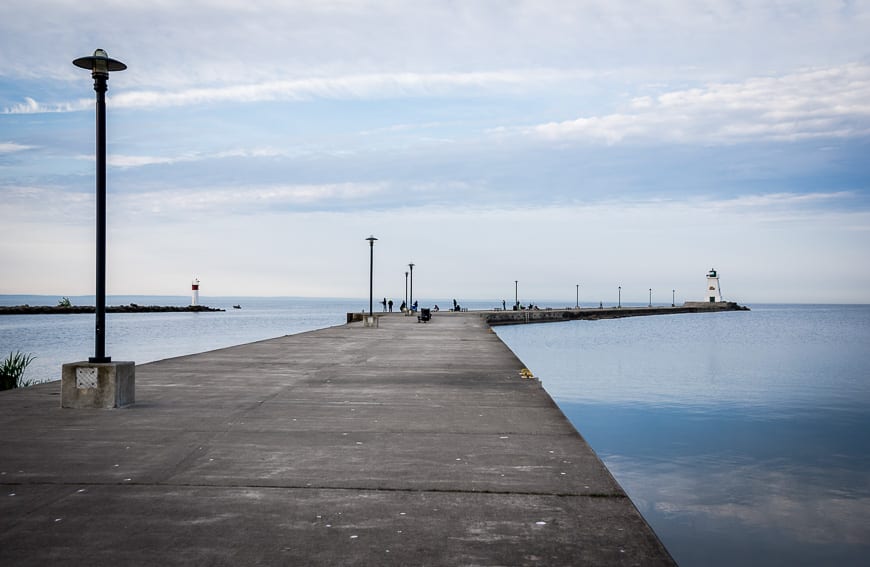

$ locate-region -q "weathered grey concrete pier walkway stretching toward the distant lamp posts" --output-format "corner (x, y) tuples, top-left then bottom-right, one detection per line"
(0, 313), (673, 566)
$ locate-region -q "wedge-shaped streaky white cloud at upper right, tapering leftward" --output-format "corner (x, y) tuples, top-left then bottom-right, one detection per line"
(520, 63), (870, 145)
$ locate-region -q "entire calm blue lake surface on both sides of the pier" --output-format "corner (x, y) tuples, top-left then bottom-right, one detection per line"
(0, 296), (870, 566)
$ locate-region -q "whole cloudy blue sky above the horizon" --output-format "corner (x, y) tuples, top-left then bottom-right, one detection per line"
(0, 0), (870, 305)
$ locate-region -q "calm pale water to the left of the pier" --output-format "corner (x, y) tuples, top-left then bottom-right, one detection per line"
(0, 295), (368, 382)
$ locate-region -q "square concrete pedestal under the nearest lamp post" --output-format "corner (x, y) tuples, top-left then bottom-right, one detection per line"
(60, 361), (136, 408)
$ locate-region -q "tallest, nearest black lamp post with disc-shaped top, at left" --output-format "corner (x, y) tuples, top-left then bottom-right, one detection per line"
(73, 49), (127, 362)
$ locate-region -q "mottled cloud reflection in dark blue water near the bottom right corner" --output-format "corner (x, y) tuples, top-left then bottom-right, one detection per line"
(601, 455), (870, 545)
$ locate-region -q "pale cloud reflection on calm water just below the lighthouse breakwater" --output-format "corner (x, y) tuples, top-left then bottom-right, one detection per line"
(497, 306), (870, 413)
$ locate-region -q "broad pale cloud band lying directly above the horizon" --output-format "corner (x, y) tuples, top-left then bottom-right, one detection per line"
(0, 183), (870, 303)
